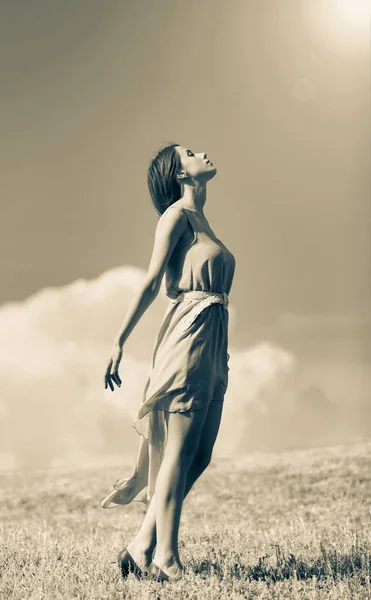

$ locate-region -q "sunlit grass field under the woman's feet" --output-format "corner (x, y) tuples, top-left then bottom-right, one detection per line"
(0, 442), (371, 600)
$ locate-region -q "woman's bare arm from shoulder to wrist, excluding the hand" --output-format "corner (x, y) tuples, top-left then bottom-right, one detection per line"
(114, 207), (187, 348)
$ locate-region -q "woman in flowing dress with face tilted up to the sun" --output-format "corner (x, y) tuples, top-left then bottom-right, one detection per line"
(101, 144), (235, 581)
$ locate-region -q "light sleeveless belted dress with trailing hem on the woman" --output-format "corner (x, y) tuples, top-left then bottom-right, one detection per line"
(101, 201), (236, 508)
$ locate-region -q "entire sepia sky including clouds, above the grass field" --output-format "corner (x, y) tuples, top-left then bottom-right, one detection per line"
(0, 0), (371, 469)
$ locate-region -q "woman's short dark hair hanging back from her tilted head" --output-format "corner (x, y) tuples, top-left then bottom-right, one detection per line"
(147, 142), (182, 215)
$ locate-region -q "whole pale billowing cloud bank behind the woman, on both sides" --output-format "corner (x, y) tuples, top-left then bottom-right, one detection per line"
(0, 266), (366, 468)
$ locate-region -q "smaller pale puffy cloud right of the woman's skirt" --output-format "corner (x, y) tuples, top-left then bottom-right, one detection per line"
(215, 341), (342, 455)
